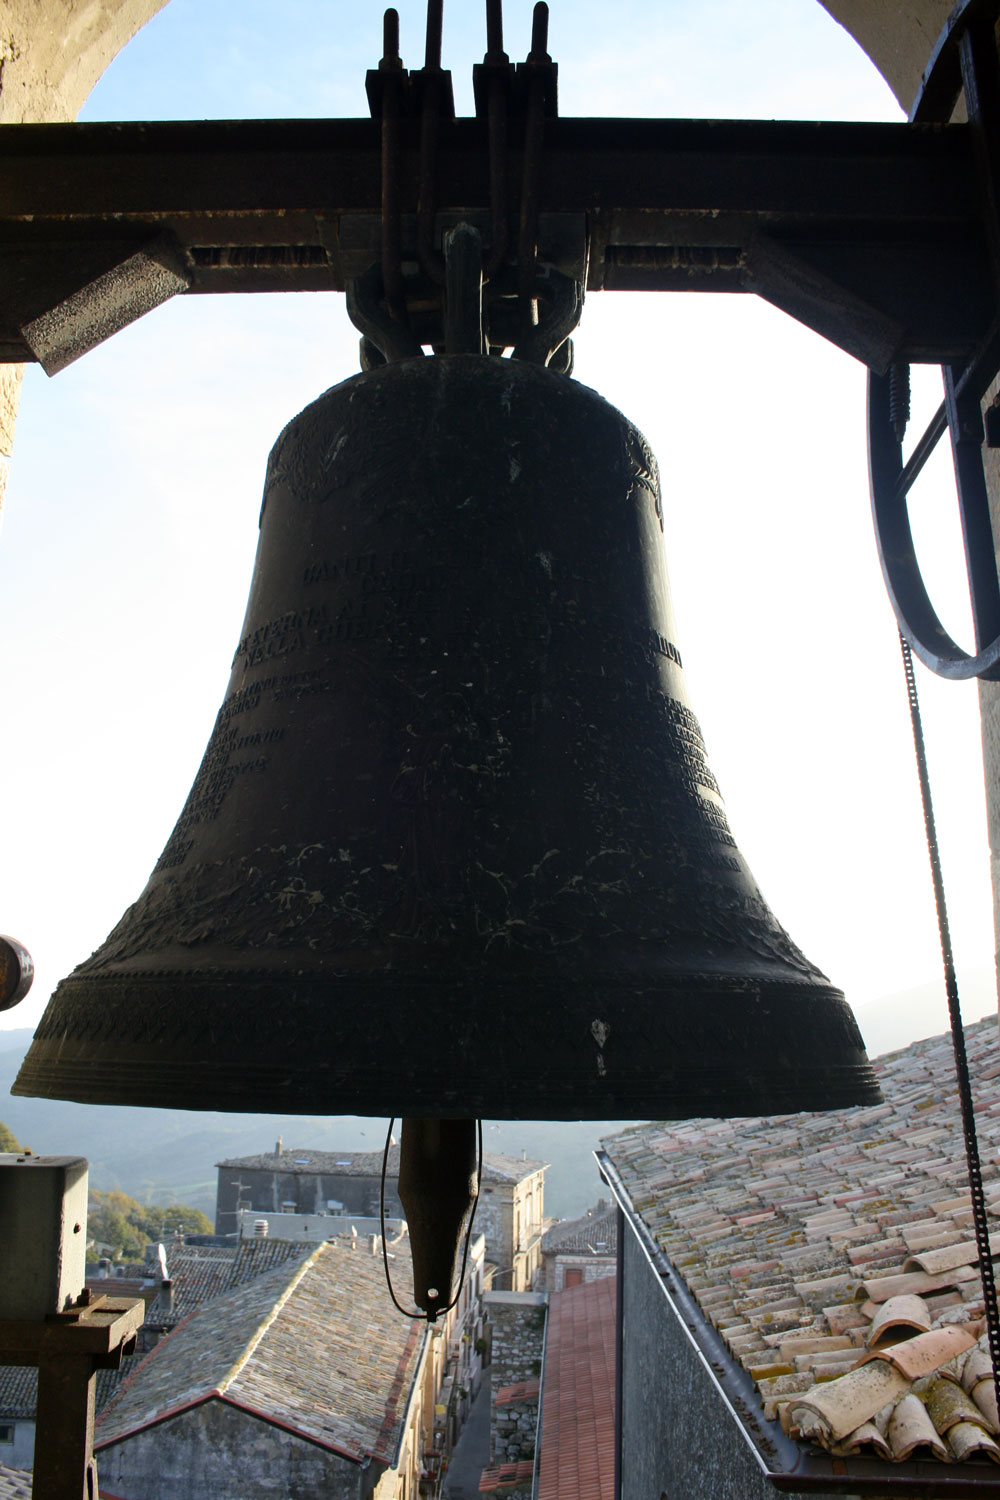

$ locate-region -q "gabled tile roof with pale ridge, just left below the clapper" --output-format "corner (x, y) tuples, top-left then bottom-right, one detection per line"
(96, 1241), (426, 1464)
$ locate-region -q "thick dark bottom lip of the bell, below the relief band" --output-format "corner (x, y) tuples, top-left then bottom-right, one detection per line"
(12, 972), (882, 1119)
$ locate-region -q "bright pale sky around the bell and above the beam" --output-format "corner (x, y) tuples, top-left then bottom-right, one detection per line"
(0, 0), (994, 1062)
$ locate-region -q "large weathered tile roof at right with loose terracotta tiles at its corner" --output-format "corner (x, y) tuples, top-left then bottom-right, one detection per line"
(604, 1017), (1000, 1463)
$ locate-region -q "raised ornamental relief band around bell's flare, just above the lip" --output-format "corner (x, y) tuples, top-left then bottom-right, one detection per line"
(75, 842), (822, 978)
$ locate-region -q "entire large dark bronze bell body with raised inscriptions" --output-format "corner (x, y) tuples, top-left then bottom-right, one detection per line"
(15, 354), (879, 1119)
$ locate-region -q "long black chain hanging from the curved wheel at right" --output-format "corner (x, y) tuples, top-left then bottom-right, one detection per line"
(900, 635), (1000, 1409)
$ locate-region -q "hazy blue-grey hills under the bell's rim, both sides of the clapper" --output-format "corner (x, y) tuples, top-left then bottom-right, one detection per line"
(0, 1029), (627, 1218)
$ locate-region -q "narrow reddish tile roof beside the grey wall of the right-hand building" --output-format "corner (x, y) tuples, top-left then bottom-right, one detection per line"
(538, 1277), (616, 1500)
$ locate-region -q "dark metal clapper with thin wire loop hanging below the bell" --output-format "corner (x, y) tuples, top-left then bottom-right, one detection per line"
(381, 1118), (483, 1323)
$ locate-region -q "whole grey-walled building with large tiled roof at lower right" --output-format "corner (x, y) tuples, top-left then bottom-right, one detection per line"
(603, 1019), (1000, 1500)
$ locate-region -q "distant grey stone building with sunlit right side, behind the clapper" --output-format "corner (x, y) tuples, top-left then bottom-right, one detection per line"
(216, 1140), (546, 1292)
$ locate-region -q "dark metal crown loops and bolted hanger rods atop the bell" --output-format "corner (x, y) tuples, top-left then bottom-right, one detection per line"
(346, 0), (578, 374)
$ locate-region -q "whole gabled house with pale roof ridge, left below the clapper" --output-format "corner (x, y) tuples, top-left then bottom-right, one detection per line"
(94, 1241), (481, 1500)
